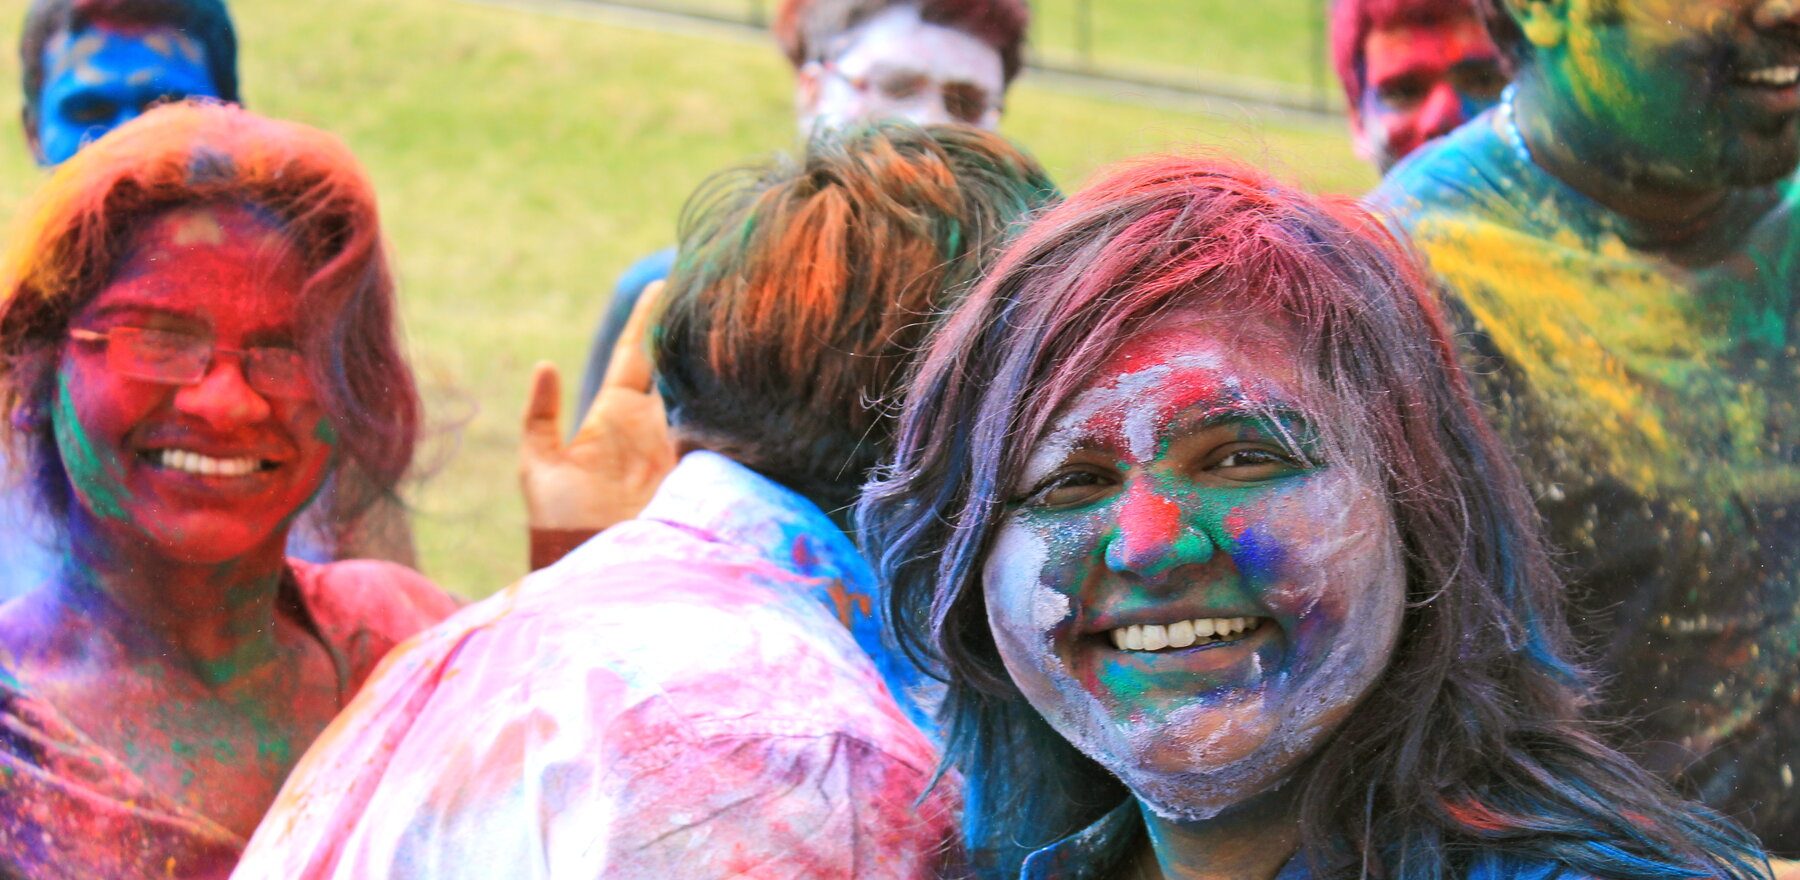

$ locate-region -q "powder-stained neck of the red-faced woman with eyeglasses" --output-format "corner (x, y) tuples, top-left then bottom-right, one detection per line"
(58, 511), (286, 686)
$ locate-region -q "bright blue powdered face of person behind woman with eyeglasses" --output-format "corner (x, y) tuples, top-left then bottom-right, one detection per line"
(36, 23), (218, 167)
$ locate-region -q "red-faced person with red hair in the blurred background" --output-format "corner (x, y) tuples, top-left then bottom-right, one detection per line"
(1330, 0), (1512, 175)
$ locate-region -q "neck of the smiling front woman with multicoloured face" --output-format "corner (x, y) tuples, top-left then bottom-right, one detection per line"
(1138, 785), (1300, 880)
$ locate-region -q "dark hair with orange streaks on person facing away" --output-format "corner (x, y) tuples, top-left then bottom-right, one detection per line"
(655, 124), (1057, 504)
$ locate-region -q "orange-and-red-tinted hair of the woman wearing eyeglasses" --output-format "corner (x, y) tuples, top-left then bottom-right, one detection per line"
(0, 101), (421, 518)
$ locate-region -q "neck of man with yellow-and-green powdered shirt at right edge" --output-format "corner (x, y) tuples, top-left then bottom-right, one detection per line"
(1514, 67), (1733, 239)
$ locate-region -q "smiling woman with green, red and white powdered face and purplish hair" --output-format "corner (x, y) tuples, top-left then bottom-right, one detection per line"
(859, 158), (1760, 880)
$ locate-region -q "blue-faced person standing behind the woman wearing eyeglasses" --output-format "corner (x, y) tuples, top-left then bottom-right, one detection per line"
(0, 0), (416, 599)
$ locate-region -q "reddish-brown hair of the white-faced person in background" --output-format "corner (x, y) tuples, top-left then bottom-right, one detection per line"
(774, 0), (1031, 83)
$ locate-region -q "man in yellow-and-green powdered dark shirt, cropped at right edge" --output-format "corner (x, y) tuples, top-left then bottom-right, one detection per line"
(1373, 0), (1800, 858)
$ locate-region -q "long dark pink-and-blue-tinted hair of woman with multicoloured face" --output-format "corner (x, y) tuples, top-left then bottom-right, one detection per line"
(859, 158), (1762, 880)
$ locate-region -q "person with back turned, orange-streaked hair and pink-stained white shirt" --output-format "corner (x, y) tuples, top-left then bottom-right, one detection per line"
(238, 126), (1055, 880)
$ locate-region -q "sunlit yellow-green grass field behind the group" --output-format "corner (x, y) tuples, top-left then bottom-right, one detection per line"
(0, 0), (1373, 596)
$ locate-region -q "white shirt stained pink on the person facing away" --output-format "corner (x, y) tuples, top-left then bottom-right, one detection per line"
(244, 453), (961, 880)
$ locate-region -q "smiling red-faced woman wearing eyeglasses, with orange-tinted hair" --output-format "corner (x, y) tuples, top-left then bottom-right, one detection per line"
(0, 103), (454, 876)
